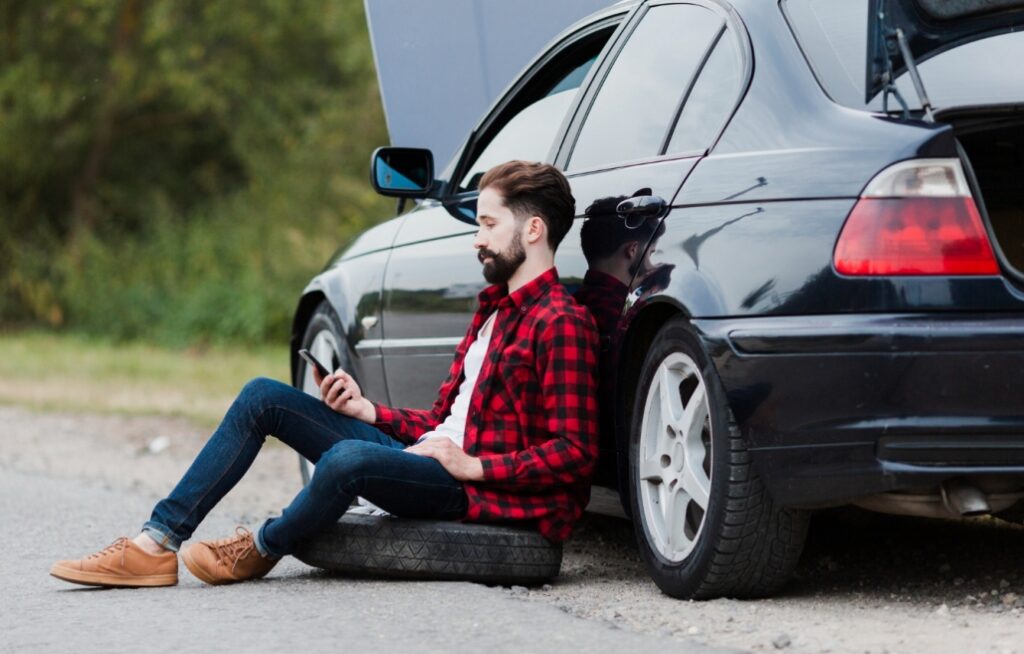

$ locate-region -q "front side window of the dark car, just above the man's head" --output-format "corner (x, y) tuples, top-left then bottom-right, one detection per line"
(459, 27), (614, 192)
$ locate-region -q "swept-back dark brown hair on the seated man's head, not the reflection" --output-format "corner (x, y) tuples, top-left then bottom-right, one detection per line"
(479, 161), (575, 250)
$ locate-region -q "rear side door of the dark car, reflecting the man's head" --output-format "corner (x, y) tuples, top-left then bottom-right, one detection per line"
(556, 2), (749, 481)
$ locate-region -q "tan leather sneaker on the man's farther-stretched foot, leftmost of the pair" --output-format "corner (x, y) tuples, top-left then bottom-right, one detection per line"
(50, 536), (178, 587)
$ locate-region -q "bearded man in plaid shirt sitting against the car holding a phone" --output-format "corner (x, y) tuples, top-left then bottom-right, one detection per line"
(50, 162), (598, 586)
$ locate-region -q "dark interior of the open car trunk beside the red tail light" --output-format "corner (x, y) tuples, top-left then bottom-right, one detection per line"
(940, 106), (1024, 278)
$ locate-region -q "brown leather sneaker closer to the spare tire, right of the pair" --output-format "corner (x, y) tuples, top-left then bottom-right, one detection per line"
(181, 527), (281, 585)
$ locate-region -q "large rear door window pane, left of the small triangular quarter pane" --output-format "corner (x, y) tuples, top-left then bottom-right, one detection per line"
(566, 4), (724, 171)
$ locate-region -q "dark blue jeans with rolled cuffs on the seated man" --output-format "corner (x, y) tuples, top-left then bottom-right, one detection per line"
(142, 379), (467, 557)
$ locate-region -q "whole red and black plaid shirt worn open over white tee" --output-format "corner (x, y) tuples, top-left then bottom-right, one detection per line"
(375, 268), (598, 541)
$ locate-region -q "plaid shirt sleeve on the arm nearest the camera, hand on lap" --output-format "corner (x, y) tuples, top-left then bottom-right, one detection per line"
(479, 313), (598, 487)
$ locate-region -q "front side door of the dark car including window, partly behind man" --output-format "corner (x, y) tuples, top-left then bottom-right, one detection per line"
(380, 10), (626, 407)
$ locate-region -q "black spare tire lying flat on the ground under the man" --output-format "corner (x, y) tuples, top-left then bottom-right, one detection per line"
(295, 514), (562, 585)
